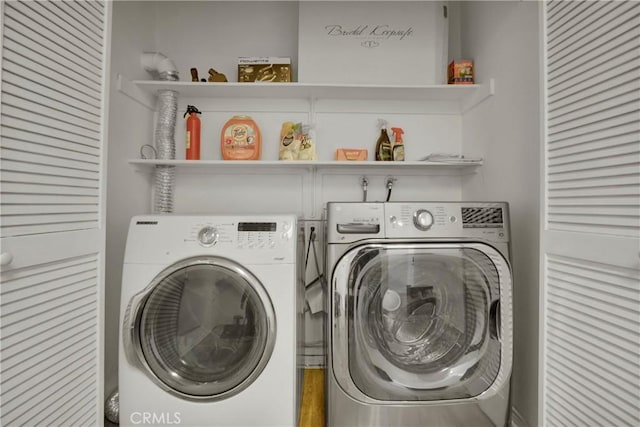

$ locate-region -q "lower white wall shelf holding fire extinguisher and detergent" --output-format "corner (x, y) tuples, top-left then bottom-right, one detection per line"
(129, 159), (482, 174)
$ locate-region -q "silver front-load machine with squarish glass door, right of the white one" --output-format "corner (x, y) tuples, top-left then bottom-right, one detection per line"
(326, 202), (512, 427)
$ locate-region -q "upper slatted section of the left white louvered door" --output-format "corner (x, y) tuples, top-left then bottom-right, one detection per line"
(0, 1), (104, 241)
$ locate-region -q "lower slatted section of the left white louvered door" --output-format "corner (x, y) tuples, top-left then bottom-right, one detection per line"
(0, 255), (98, 425)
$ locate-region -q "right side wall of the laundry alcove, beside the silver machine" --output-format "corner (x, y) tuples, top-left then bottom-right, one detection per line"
(460, 1), (541, 427)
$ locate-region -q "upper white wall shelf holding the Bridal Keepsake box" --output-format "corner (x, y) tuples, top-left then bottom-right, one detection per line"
(118, 75), (494, 111)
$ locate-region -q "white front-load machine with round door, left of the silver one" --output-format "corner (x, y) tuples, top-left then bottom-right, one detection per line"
(119, 215), (298, 427)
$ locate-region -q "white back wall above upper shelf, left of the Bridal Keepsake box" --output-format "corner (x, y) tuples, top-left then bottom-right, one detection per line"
(149, 1), (298, 82)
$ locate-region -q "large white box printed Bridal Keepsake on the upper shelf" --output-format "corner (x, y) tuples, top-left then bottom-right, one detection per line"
(298, 1), (448, 85)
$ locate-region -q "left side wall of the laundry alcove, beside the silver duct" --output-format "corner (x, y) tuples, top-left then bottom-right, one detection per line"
(105, 1), (155, 397)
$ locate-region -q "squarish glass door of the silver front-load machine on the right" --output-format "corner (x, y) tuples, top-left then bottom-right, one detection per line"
(332, 244), (510, 401)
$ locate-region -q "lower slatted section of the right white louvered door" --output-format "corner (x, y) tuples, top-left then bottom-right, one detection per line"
(545, 256), (640, 426)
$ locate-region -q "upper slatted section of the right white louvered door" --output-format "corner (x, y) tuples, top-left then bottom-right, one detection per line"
(546, 2), (640, 236)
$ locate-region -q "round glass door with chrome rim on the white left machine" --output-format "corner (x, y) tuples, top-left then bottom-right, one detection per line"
(131, 257), (276, 399)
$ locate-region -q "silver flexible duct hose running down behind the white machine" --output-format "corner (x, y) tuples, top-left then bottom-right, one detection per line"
(141, 52), (178, 213)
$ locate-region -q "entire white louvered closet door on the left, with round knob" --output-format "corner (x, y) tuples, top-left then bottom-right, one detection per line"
(0, 0), (111, 426)
